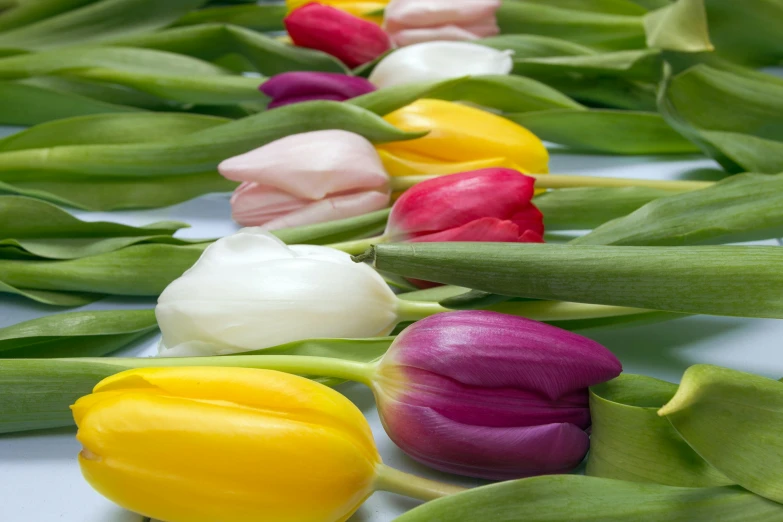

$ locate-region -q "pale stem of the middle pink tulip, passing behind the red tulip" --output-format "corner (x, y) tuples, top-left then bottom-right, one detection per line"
(391, 174), (714, 192)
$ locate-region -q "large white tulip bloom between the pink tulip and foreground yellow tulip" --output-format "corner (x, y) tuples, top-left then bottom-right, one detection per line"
(155, 228), (398, 357)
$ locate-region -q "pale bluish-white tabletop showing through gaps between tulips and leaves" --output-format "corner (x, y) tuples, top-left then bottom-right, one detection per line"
(0, 140), (783, 522)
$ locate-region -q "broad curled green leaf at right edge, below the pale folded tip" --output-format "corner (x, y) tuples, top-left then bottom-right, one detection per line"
(658, 65), (783, 174)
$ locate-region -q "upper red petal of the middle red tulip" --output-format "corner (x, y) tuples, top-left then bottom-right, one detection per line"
(386, 168), (543, 241)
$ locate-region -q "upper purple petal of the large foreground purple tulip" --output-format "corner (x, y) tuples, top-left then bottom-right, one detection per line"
(383, 310), (622, 400)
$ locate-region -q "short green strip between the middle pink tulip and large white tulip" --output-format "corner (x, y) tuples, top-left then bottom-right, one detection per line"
(272, 208), (391, 245)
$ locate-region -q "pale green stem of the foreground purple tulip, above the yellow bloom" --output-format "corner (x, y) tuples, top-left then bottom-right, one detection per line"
(96, 355), (375, 386)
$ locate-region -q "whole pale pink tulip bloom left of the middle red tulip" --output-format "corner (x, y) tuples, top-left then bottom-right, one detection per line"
(218, 130), (390, 230)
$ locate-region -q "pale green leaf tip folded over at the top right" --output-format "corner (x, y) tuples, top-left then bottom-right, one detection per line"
(644, 0), (715, 53)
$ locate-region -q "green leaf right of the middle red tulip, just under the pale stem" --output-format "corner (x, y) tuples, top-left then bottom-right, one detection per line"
(533, 187), (672, 231)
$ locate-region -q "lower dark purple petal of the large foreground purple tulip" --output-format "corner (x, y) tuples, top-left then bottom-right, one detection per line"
(381, 399), (590, 480)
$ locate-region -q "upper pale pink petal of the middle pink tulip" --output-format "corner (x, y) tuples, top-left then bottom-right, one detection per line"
(218, 130), (389, 200)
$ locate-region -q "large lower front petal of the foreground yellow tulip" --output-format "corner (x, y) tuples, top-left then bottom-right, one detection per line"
(78, 390), (378, 522)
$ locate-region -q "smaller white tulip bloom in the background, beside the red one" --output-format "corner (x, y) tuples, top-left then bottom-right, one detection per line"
(370, 42), (514, 88)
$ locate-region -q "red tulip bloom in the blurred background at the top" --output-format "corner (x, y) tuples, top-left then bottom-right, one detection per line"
(284, 4), (391, 67)
